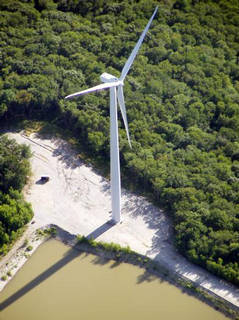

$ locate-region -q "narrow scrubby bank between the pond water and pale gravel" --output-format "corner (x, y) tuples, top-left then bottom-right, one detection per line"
(0, 225), (239, 320)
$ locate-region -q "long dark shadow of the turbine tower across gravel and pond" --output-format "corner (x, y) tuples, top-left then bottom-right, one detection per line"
(0, 221), (114, 311)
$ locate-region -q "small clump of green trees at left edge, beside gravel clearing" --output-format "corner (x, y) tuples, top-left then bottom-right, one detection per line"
(0, 136), (33, 255)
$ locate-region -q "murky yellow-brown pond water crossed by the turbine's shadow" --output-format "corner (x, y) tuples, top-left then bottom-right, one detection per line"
(0, 240), (227, 320)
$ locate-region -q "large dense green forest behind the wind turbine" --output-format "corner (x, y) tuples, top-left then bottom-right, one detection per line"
(0, 0), (239, 284)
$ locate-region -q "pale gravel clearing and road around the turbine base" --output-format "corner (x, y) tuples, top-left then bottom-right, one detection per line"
(5, 133), (239, 307)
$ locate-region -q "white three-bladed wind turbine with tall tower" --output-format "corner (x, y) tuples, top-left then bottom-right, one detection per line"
(65, 7), (158, 223)
